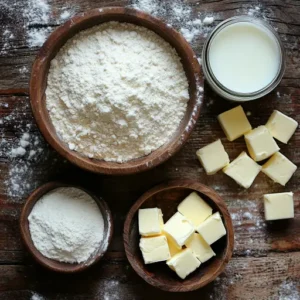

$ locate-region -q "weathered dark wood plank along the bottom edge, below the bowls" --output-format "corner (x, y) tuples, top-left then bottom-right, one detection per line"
(0, 253), (300, 300)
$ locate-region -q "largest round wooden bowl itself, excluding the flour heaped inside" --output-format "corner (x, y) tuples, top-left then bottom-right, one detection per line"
(30, 7), (203, 174)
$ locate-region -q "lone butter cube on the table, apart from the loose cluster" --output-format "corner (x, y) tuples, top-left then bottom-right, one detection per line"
(264, 192), (294, 221)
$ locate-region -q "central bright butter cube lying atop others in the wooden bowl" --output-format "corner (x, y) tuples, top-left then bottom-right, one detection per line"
(164, 212), (195, 249)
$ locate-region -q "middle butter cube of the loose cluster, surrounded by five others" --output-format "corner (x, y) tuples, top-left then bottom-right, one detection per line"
(245, 126), (280, 161)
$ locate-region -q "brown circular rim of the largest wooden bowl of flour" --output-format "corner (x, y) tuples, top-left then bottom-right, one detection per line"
(30, 7), (204, 175)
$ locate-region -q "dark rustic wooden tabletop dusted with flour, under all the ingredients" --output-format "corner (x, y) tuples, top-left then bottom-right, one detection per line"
(0, 0), (300, 300)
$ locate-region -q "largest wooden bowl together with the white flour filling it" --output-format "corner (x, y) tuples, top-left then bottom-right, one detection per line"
(30, 7), (203, 174)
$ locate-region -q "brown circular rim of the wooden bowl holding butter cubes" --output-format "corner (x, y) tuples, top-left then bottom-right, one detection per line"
(123, 179), (234, 292)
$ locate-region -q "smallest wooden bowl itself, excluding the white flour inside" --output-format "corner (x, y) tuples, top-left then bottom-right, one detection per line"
(20, 182), (113, 273)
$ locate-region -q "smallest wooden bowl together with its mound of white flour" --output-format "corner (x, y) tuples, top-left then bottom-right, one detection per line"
(20, 182), (113, 273)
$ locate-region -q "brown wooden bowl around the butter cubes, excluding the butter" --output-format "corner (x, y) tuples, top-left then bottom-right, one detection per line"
(123, 180), (234, 292)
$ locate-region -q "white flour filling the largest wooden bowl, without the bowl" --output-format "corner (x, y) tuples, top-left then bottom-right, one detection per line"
(46, 22), (189, 162)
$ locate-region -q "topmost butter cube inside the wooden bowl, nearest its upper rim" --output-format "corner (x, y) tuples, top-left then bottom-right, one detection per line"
(177, 192), (212, 226)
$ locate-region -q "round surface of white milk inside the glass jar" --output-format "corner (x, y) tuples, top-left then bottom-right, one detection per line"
(208, 22), (281, 93)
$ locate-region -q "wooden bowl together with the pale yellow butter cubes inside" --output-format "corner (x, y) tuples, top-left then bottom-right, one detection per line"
(123, 180), (234, 292)
